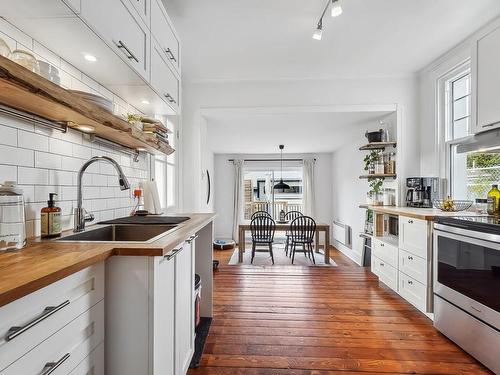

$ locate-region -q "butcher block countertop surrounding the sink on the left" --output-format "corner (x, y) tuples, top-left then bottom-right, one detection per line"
(0, 214), (215, 306)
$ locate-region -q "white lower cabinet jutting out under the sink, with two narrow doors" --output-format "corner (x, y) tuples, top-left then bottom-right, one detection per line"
(106, 236), (195, 375)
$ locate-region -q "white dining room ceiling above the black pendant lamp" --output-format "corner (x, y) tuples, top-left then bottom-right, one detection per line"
(206, 112), (390, 154)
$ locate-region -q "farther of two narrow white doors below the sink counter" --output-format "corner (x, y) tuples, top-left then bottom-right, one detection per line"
(175, 242), (194, 375)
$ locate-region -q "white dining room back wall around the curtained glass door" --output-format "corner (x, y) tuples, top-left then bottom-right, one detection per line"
(214, 154), (332, 238)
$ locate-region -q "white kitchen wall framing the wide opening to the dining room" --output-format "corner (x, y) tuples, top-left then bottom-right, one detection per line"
(182, 77), (420, 211)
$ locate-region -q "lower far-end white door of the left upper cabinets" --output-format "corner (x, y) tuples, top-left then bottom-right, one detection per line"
(151, 43), (179, 112)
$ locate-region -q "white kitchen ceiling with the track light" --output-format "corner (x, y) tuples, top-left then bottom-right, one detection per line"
(163, 0), (500, 80)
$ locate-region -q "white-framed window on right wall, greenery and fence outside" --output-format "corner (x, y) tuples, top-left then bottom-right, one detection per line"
(445, 65), (500, 201)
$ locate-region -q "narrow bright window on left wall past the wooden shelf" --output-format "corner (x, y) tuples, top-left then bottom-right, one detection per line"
(154, 119), (178, 212)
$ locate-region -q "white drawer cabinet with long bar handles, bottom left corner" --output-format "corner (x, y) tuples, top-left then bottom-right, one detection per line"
(0, 263), (104, 375)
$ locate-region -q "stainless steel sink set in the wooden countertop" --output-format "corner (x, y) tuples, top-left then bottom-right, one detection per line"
(57, 224), (177, 243)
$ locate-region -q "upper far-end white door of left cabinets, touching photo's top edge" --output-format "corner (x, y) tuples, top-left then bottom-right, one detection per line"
(151, 0), (181, 70)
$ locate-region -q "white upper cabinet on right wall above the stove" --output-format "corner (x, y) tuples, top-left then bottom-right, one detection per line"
(472, 23), (500, 133)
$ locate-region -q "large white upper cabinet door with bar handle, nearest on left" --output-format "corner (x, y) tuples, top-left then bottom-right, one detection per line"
(81, 0), (150, 82)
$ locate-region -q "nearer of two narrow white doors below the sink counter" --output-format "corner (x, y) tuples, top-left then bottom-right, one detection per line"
(153, 250), (175, 375)
